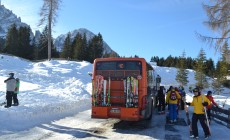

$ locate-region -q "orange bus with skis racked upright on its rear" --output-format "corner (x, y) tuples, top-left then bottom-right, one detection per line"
(91, 58), (160, 121)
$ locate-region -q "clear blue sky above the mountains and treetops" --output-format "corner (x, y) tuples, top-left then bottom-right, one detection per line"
(2, 0), (220, 61)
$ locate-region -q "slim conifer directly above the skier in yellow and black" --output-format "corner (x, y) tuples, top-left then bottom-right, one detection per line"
(195, 48), (209, 89)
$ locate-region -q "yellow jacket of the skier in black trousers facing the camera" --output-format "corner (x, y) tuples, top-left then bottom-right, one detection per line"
(190, 94), (211, 114)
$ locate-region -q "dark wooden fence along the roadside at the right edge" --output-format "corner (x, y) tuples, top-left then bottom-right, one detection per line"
(211, 106), (230, 128)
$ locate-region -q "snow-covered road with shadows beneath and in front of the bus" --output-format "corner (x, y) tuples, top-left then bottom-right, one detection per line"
(0, 106), (229, 140)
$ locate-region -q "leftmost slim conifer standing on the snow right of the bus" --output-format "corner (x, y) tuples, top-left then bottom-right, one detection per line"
(176, 52), (188, 86)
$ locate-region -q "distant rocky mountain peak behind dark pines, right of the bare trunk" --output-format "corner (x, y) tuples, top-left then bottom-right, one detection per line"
(54, 28), (117, 53)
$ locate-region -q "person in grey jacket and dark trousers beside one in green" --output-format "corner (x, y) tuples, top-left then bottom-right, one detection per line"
(4, 73), (16, 108)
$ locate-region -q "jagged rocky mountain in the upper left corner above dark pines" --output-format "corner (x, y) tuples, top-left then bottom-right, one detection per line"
(0, 5), (33, 38)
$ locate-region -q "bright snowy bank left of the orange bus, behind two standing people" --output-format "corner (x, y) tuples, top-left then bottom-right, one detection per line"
(0, 55), (92, 134)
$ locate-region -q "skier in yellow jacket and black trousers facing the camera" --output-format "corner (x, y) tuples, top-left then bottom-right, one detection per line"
(186, 88), (210, 139)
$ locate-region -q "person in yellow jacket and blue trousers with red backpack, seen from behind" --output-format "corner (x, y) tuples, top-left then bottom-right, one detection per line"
(166, 87), (181, 123)
